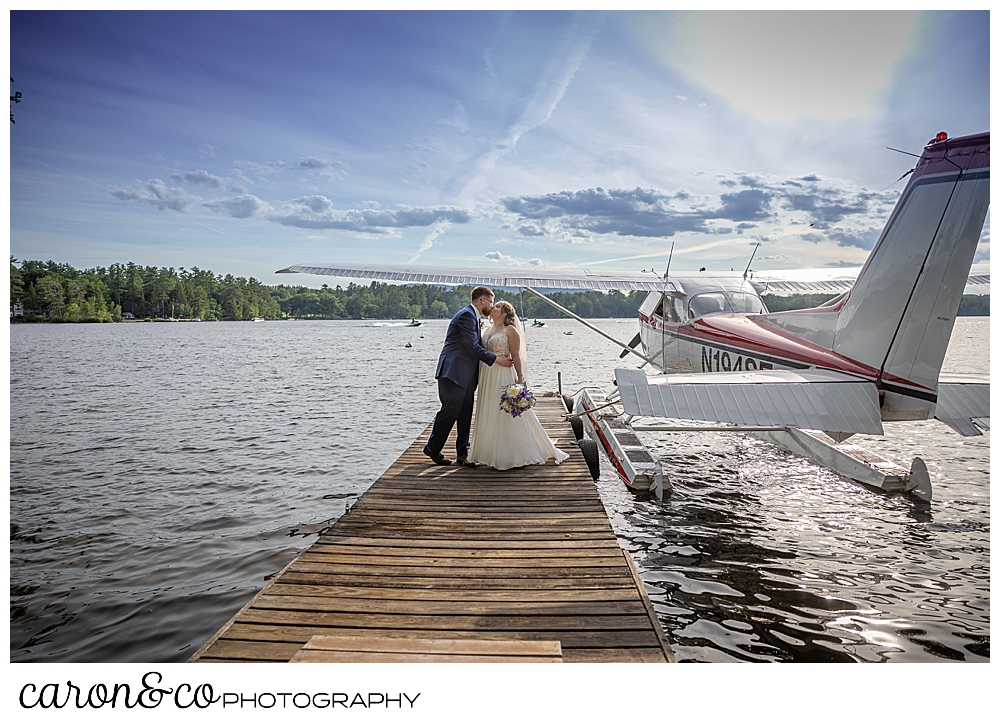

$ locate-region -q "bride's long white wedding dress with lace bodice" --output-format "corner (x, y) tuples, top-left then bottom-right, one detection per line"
(469, 329), (569, 469)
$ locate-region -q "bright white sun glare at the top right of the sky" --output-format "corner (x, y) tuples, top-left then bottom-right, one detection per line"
(644, 11), (917, 123)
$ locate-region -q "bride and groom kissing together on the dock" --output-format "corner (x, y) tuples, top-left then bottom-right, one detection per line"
(424, 286), (569, 469)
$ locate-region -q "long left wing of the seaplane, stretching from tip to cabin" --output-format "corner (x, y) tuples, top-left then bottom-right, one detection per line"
(275, 264), (675, 291)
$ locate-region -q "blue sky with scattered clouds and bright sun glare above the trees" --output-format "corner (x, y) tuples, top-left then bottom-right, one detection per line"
(10, 11), (989, 285)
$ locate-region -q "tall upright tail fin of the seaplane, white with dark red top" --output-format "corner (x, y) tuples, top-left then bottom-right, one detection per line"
(832, 133), (990, 419)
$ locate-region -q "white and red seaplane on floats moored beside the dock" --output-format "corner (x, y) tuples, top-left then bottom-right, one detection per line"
(276, 132), (990, 502)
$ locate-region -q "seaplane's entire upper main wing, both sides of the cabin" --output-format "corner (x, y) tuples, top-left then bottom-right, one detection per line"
(275, 263), (990, 294)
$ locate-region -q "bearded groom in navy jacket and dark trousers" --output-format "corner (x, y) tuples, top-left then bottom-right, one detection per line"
(424, 286), (514, 467)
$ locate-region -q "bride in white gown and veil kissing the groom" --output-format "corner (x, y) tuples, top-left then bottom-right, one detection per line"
(469, 301), (569, 469)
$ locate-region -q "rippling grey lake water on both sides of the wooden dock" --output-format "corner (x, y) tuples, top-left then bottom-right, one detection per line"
(10, 318), (990, 662)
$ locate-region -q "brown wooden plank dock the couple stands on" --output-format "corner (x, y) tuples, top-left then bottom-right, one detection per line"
(191, 397), (674, 663)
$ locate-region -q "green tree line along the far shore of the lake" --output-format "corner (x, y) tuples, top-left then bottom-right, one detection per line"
(10, 257), (989, 322)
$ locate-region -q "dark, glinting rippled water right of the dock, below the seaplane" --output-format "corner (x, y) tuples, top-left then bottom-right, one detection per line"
(601, 382), (989, 662)
